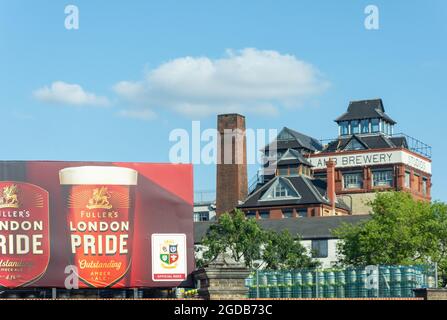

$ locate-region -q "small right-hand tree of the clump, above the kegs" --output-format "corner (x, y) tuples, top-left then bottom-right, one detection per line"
(262, 230), (319, 270)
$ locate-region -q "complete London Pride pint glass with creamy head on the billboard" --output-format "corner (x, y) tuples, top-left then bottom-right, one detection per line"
(59, 166), (138, 288)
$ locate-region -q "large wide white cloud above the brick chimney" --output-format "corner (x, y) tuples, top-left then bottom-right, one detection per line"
(114, 49), (329, 116)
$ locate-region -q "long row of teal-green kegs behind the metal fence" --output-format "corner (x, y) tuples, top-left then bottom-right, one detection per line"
(246, 265), (437, 298)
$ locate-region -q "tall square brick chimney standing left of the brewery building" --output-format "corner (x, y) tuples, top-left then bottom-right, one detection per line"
(216, 114), (248, 216)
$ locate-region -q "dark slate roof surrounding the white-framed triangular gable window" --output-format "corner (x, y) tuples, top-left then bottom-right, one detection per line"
(238, 175), (350, 211)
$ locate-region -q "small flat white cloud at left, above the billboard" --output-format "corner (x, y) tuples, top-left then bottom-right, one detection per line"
(33, 81), (110, 107)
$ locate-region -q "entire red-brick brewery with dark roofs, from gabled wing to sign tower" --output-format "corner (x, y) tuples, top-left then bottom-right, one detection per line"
(217, 99), (431, 219)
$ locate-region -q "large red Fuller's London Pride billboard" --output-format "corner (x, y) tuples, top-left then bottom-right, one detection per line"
(0, 161), (194, 289)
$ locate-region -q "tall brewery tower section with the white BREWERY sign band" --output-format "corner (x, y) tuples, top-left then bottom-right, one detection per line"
(308, 99), (432, 214)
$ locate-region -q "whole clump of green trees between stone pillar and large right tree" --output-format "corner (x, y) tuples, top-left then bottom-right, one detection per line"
(197, 210), (315, 269)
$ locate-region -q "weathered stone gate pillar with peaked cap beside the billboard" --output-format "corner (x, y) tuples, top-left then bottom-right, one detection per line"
(193, 256), (250, 300)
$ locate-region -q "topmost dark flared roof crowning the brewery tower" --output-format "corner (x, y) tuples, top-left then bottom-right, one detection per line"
(335, 99), (396, 124)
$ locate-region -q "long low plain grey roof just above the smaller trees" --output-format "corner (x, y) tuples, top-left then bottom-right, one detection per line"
(194, 215), (370, 244)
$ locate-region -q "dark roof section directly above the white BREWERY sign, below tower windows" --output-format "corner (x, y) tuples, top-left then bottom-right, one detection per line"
(323, 134), (408, 152)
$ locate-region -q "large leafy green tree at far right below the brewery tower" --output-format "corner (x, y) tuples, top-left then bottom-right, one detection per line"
(334, 192), (447, 286)
